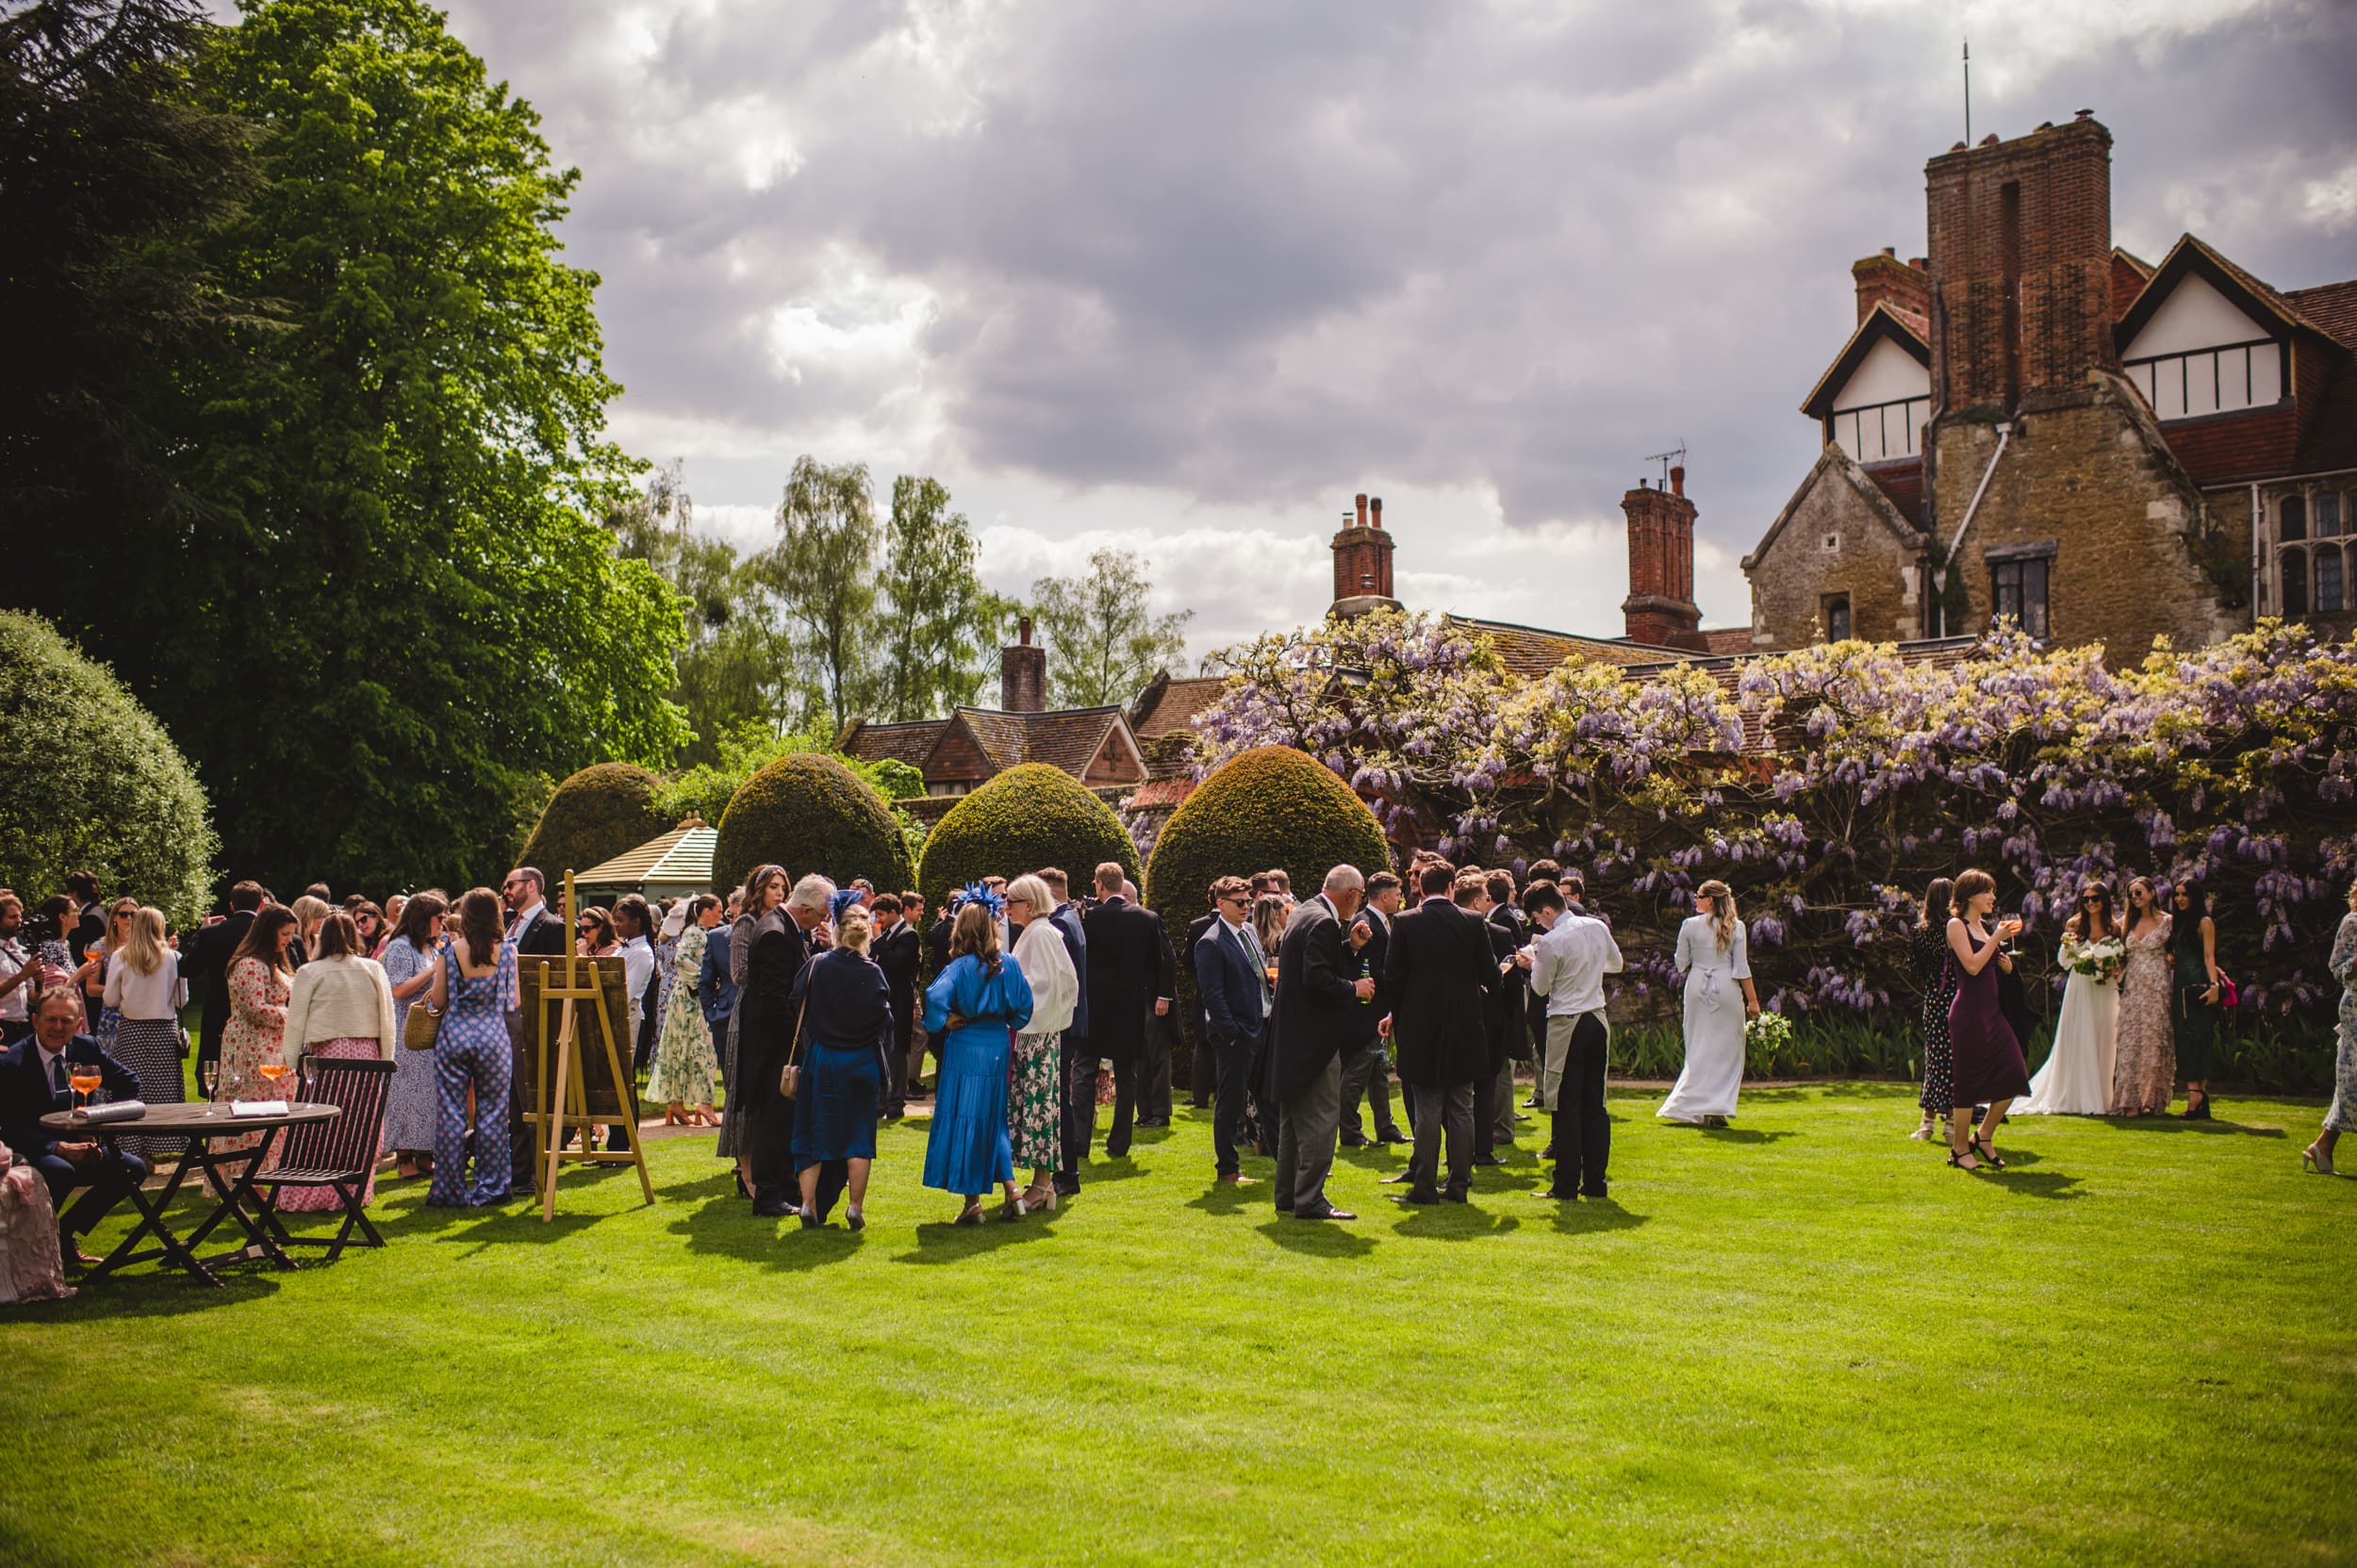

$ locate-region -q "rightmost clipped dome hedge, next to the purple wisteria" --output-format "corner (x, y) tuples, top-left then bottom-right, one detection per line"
(1144, 745), (1391, 1065)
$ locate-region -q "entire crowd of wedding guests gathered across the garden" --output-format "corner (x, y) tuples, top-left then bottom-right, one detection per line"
(0, 851), (2357, 1299)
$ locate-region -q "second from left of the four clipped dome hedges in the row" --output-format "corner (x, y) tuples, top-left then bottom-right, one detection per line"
(712, 752), (913, 894)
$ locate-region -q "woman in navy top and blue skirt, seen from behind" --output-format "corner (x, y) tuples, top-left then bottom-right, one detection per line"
(785, 903), (891, 1230)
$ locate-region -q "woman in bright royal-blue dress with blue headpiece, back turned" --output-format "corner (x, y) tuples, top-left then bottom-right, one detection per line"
(924, 886), (1032, 1226)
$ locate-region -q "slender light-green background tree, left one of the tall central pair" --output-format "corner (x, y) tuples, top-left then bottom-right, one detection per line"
(762, 455), (877, 729)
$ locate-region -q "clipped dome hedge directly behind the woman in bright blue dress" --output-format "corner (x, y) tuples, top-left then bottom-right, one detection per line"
(917, 762), (1146, 910)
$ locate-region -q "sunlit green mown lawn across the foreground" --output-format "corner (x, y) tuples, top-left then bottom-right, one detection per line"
(0, 1084), (2357, 1568)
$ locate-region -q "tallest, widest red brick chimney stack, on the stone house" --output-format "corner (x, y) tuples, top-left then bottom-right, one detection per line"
(1923, 113), (2119, 413)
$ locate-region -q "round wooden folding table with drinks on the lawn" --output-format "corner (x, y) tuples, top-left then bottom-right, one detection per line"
(41, 1101), (344, 1285)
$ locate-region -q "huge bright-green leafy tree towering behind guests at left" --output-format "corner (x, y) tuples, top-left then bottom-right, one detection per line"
(23, 0), (684, 886)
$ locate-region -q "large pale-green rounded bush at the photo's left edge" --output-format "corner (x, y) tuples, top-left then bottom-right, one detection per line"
(0, 611), (220, 924)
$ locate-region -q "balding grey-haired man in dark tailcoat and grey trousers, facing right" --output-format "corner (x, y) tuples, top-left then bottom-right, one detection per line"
(1273, 866), (1375, 1219)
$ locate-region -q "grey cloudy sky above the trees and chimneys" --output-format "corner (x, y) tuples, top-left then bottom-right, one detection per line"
(424, 0), (2357, 653)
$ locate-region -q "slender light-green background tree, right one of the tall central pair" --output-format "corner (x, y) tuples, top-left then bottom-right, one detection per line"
(875, 474), (1012, 724)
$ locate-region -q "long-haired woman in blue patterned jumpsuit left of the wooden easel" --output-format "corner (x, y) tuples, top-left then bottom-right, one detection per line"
(427, 886), (517, 1207)
